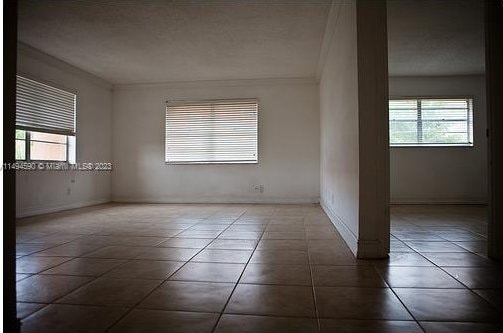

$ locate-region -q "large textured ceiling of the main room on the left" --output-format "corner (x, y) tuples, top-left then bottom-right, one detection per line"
(18, 0), (330, 84)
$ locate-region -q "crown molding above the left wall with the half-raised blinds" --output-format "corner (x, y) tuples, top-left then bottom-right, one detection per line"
(17, 42), (113, 90)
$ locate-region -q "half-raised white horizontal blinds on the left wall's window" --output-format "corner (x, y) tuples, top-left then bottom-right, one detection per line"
(16, 75), (76, 135)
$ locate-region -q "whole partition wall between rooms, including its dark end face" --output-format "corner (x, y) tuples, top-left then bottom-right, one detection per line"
(320, 1), (389, 258)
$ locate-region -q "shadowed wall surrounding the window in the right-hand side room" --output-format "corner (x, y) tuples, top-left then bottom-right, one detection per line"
(389, 75), (487, 203)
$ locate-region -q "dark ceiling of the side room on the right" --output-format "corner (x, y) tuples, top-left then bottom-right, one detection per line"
(388, 0), (485, 76)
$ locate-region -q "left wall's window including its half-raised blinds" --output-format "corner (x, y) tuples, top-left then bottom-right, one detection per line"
(16, 75), (76, 163)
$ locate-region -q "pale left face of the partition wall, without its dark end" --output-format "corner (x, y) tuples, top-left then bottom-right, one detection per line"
(320, 2), (359, 253)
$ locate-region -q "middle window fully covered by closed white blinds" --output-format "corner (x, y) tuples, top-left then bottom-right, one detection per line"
(166, 99), (258, 164)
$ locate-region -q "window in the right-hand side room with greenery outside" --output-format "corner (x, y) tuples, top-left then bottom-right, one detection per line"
(389, 98), (473, 146)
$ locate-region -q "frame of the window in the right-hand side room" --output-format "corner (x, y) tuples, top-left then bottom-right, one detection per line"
(388, 95), (475, 148)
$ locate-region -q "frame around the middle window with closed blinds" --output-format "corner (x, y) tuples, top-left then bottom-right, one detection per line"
(164, 97), (260, 165)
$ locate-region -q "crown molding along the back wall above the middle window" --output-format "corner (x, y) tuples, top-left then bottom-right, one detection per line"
(113, 77), (318, 90)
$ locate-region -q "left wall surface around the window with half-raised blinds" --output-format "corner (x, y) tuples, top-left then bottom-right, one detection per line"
(16, 45), (112, 217)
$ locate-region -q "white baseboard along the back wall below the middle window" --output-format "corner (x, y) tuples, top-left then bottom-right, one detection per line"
(112, 196), (319, 204)
